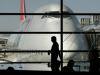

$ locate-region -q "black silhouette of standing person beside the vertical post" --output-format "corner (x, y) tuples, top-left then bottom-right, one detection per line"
(51, 36), (61, 71)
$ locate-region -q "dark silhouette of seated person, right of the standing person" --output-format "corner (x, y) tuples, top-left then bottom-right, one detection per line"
(62, 60), (75, 72)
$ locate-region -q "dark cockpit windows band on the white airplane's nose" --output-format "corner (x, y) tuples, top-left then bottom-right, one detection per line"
(41, 11), (70, 19)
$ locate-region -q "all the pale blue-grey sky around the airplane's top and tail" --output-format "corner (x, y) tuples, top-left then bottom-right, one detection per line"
(0, 0), (100, 31)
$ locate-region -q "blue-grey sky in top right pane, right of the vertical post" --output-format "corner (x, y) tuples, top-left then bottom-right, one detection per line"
(63, 0), (100, 13)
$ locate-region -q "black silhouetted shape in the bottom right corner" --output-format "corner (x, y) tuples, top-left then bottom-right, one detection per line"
(89, 50), (100, 72)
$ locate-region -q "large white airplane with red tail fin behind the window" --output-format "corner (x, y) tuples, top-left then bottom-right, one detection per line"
(0, 0), (88, 70)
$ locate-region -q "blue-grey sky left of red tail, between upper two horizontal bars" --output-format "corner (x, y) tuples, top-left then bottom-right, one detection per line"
(0, 15), (21, 32)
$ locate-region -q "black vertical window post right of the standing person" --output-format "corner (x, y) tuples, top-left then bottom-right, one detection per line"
(60, 0), (63, 70)
